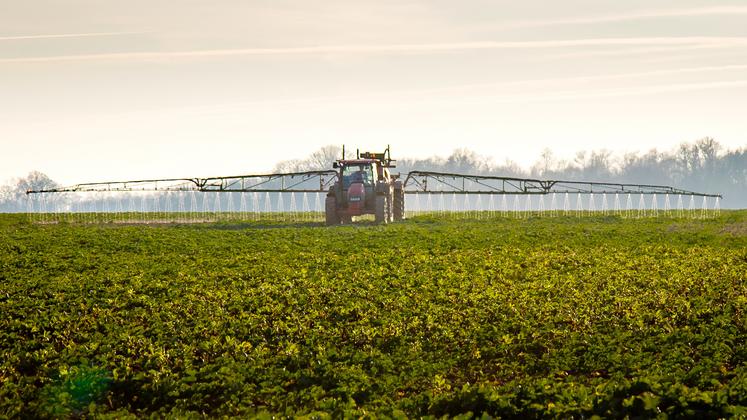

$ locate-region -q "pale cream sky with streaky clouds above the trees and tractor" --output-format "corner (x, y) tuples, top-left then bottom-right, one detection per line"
(0, 0), (747, 184)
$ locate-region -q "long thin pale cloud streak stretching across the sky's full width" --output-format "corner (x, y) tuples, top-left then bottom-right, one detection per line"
(0, 36), (747, 63)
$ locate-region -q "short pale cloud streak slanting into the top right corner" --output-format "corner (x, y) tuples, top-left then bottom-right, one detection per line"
(505, 6), (747, 28)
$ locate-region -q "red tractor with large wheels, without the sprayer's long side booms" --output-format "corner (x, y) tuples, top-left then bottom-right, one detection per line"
(325, 147), (405, 225)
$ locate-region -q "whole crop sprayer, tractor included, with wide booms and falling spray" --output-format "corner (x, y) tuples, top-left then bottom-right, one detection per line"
(26, 146), (721, 225)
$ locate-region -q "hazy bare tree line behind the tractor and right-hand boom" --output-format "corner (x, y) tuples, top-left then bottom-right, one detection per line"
(275, 137), (747, 208)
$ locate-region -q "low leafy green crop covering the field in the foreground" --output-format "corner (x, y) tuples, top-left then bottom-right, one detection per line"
(0, 212), (747, 418)
